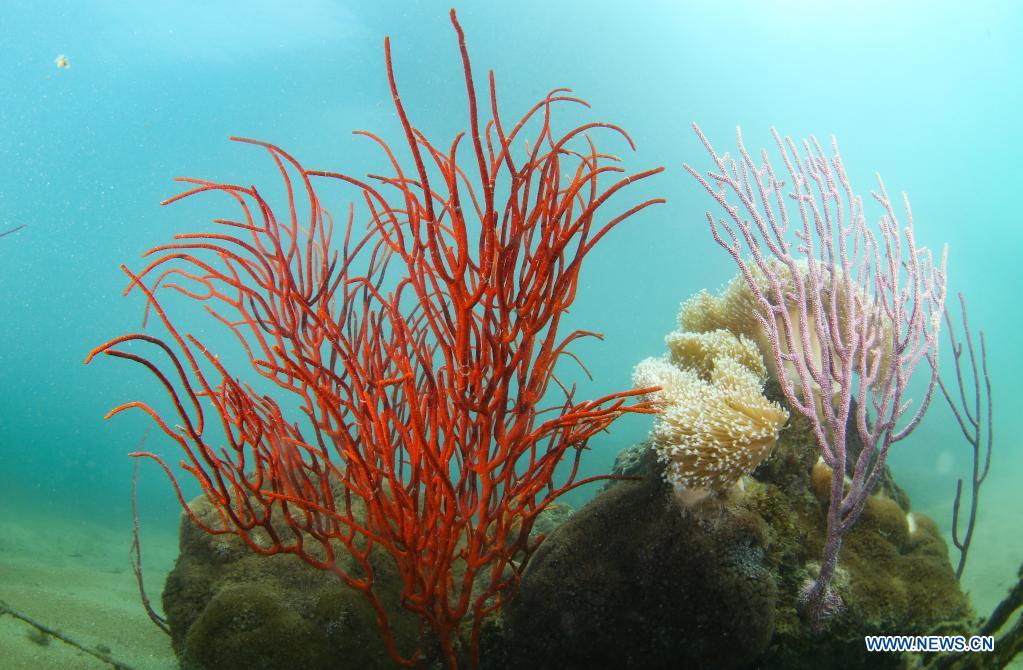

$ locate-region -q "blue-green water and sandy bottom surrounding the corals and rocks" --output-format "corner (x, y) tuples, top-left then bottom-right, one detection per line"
(0, 0), (1023, 668)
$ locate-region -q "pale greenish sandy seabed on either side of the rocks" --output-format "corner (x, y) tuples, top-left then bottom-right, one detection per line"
(0, 487), (1023, 670)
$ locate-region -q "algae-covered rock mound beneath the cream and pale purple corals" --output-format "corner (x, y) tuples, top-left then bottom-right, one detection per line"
(505, 407), (973, 669)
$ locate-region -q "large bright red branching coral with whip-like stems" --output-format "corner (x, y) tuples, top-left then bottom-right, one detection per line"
(89, 11), (662, 668)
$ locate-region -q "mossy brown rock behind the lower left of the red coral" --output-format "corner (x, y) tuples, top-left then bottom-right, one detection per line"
(164, 498), (418, 670)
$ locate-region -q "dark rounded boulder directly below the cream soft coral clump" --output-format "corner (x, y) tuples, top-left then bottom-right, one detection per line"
(504, 443), (777, 668)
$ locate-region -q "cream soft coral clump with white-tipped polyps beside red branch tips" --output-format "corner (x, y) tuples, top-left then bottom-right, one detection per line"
(633, 329), (789, 502)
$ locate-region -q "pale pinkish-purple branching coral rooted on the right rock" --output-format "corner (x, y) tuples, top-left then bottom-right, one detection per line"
(683, 125), (947, 626)
